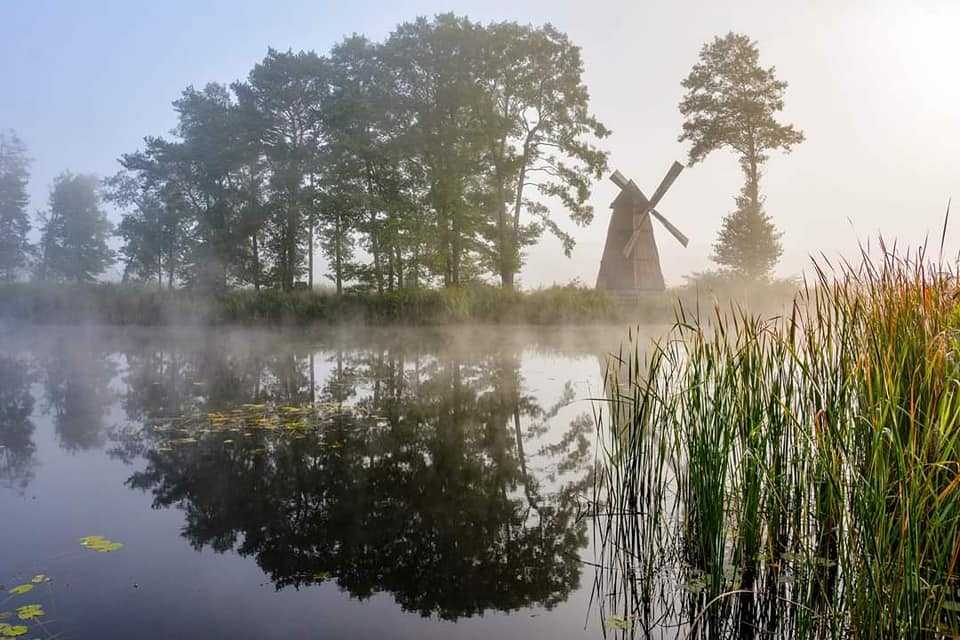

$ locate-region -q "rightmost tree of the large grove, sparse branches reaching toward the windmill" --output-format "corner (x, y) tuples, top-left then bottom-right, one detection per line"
(477, 22), (610, 289)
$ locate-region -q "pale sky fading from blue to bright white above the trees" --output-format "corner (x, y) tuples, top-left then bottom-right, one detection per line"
(0, 0), (960, 286)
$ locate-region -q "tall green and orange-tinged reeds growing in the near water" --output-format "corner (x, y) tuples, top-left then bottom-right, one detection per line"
(595, 249), (960, 638)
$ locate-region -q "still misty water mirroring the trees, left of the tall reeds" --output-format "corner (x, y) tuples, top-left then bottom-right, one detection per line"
(0, 328), (656, 639)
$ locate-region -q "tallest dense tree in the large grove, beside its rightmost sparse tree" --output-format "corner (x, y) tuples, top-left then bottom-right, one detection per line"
(380, 14), (483, 286)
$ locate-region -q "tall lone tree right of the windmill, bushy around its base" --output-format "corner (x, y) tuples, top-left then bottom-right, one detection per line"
(679, 33), (804, 279)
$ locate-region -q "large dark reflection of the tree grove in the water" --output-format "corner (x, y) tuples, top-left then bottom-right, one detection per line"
(120, 340), (591, 619)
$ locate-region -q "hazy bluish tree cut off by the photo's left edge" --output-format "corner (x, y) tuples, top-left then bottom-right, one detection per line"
(0, 131), (32, 282)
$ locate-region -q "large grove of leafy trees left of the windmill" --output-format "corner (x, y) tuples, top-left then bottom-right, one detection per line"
(108, 14), (609, 291)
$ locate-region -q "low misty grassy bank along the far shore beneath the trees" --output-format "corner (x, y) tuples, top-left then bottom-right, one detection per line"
(0, 283), (786, 326)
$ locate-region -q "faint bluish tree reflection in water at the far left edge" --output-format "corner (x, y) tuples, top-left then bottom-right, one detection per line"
(0, 355), (36, 491)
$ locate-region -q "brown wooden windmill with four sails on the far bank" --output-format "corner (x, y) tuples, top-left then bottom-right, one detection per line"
(597, 162), (689, 295)
